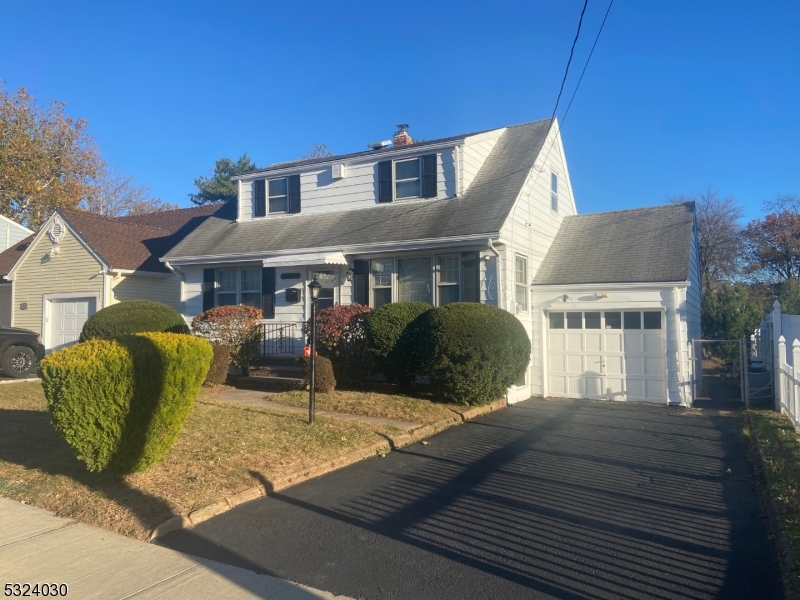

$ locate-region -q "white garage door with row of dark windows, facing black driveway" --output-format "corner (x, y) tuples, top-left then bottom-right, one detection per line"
(547, 310), (667, 402)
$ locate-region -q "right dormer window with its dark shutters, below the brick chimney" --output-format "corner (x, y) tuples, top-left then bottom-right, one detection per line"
(378, 154), (439, 202)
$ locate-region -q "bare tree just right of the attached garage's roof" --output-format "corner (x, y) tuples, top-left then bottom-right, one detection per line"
(669, 187), (744, 290)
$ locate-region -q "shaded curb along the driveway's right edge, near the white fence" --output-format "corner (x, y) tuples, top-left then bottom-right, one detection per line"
(745, 413), (800, 600)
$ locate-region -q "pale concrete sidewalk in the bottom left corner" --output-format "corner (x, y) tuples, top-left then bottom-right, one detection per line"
(0, 498), (345, 600)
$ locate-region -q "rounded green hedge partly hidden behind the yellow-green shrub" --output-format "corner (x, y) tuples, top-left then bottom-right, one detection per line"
(80, 300), (189, 342)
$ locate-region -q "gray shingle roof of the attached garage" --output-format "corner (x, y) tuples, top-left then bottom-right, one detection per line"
(533, 202), (694, 285)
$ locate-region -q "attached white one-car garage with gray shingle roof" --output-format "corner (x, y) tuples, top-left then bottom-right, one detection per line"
(531, 203), (700, 406)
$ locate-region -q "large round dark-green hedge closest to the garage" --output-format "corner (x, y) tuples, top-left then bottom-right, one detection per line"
(414, 302), (531, 405)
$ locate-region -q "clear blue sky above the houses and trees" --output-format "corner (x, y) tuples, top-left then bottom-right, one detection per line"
(0, 0), (800, 223)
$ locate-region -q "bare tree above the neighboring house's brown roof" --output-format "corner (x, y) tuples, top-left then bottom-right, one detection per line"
(78, 169), (180, 217)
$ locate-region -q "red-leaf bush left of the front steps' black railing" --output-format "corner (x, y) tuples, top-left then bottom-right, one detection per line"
(192, 306), (262, 375)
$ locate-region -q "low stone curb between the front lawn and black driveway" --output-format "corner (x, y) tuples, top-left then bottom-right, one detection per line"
(148, 398), (507, 542)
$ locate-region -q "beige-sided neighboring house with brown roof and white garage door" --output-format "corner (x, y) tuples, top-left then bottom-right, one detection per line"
(0, 206), (220, 351)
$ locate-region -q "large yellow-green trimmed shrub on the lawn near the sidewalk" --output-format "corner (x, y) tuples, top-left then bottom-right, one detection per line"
(39, 333), (213, 474)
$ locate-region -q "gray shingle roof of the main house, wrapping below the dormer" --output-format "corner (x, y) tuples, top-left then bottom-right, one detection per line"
(164, 119), (550, 260)
